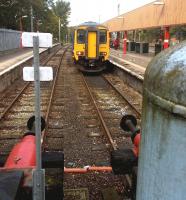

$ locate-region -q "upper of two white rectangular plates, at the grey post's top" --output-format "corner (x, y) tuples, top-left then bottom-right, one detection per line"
(22, 32), (52, 48)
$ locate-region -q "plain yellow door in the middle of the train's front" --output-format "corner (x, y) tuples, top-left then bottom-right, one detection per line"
(88, 31), (97, 59)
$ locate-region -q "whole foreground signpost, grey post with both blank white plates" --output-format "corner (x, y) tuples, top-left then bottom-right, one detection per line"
(22, 33), (53, 200)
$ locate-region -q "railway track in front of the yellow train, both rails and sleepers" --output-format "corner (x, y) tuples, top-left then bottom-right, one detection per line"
(84, 76), (141, 150)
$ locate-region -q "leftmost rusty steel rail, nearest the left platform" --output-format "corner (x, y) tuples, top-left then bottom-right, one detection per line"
(0, 45), (61, 120)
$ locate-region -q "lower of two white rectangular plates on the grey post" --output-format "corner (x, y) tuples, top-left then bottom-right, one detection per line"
(23, 66), (53, 81)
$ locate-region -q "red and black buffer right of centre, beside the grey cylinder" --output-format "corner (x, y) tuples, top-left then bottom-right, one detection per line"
(111, 115), (141, 199)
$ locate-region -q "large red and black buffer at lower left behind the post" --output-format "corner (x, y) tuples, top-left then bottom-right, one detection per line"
(0, 117), (64, 200)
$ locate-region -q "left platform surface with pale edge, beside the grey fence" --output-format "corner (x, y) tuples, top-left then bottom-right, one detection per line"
(0, 48), (45, 75)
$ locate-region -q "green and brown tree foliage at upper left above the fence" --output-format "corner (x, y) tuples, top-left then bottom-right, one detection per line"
(0, 0), (70, 41)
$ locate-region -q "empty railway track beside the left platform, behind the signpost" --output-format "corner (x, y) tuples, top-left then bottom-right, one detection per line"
(0, 46), (67, 159)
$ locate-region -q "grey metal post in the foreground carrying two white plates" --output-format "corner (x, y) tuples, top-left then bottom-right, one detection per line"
(33, 36), (45, 200)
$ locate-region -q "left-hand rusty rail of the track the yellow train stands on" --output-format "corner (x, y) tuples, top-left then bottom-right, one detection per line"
(82, 75), (118, 150)
